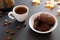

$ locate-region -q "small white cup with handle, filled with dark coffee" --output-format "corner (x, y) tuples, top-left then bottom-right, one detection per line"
(8, 5), (29, 22)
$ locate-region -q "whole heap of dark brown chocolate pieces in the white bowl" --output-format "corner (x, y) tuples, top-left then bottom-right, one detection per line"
(34, 13), (55, 32)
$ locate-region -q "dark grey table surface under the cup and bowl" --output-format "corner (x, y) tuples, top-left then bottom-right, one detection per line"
(0, 0), (60, 40)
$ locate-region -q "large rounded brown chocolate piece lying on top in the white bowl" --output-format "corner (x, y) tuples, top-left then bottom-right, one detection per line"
(40, 13), (55, 24)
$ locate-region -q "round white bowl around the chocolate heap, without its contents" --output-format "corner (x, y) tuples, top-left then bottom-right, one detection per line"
(29, 12), (58, 34)
